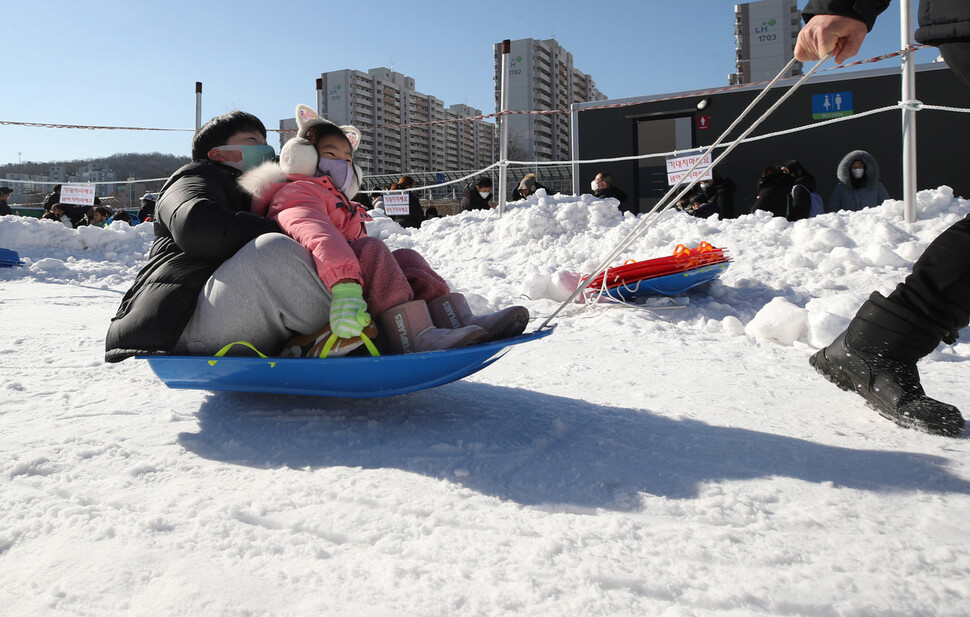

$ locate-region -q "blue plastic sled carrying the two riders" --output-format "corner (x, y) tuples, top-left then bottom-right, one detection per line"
(138, 326), (555, 398)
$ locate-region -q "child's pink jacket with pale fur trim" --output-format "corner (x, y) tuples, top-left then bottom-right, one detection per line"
(239, 161), (373, 289)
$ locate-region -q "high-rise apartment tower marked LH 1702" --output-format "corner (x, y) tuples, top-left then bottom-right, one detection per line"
(494, 39), (606, 161)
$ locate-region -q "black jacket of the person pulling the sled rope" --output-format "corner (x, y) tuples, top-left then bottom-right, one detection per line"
(802, 0), (970, 45)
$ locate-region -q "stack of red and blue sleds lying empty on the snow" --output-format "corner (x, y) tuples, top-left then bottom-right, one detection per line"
(587, 242), (731, 302)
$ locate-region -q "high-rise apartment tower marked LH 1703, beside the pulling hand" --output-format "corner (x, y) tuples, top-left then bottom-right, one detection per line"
(728, 0), (802, 85)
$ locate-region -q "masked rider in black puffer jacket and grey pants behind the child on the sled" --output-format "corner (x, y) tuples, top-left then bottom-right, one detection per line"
(105, 112), (316, 362)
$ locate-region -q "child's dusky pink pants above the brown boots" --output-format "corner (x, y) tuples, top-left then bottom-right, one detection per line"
(350, 236), (450, 317)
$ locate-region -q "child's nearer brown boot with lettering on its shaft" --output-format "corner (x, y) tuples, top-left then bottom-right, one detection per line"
(381, 300), (488, 354)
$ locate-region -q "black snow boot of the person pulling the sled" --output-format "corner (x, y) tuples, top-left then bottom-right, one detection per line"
(809, 293), (964, 437)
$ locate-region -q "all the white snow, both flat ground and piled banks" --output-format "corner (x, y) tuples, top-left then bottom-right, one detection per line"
(0, 187), (970, 617)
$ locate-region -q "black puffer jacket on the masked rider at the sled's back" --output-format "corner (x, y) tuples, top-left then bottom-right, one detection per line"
(105, 161), (281, 362)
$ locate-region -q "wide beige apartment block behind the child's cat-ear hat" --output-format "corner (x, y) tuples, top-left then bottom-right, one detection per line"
(280, 68), (496, 175)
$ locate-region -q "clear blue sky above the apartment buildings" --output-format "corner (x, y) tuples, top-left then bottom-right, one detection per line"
(0, 0), (935, 164)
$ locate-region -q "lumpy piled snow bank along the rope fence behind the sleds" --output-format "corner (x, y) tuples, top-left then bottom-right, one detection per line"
(0, 186), (970, 348)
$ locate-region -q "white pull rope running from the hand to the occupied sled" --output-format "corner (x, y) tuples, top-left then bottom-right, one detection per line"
(538, 52), (833, 330)
